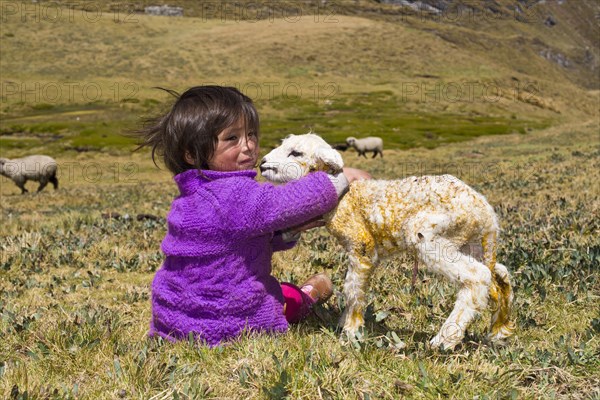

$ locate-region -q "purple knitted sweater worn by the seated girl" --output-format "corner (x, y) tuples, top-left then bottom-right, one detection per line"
(150, 170), (338, 346)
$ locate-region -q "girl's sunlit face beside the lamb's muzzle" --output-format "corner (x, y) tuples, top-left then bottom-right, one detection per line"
(208, 118), (259, 171)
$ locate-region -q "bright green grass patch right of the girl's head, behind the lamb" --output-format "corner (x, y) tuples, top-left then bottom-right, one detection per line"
(262, 91), (551, 149)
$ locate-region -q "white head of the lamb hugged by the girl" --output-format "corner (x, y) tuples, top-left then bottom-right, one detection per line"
(260, 133), (344, 183)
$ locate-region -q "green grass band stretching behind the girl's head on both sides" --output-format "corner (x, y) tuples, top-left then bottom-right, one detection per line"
(0, 91), (552, 154)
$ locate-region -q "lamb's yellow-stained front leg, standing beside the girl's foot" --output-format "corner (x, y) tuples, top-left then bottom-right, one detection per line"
(339, 249), (377, 337)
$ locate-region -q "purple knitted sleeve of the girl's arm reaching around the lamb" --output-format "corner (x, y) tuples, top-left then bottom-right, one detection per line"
(233, 172), (338, 237)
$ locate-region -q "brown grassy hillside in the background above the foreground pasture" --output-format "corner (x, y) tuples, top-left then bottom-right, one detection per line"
(0, 0), (600, 152)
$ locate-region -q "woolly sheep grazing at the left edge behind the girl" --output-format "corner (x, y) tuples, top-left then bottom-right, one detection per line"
(0, 155), (58, 194)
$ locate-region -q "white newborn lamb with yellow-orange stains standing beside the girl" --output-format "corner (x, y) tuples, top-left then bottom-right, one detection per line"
(260, 134), (514, 349)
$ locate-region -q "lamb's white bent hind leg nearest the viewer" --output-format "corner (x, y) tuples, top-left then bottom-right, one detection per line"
(417, 233), (492, 349)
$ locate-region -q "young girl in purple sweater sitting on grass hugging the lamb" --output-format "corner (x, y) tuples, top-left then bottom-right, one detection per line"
(139, 86), (369, 346)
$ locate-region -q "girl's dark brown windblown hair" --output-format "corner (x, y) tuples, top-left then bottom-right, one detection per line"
(133, 86), (259, 175)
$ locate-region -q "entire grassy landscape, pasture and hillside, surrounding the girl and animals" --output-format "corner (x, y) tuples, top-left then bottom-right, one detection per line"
(0, 0), (600, 400)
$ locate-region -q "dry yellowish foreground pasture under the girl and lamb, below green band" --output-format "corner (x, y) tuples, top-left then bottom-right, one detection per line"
(0, 122), (600, 399)
